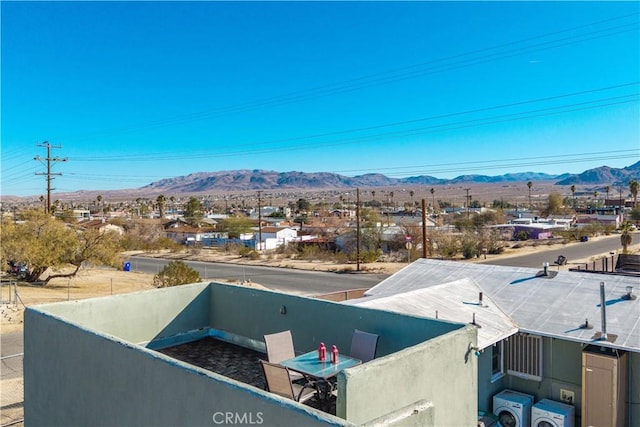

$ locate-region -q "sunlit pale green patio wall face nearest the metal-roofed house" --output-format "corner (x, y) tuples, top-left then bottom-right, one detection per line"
(337, 326), (478, 426)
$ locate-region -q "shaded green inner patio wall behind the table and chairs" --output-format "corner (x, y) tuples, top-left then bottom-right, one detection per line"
(206, 283), (461, 357)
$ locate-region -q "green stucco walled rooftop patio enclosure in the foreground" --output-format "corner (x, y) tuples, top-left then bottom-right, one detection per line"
(24, 283), (478, 427)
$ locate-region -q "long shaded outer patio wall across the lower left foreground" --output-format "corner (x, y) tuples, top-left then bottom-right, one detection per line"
(24, 310), (346, 427)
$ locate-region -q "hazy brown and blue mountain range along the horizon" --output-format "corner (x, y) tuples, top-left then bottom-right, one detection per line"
(145, 161), (640, 193)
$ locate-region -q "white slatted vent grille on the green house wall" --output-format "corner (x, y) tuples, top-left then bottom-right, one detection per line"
(506, 334), (542, 381)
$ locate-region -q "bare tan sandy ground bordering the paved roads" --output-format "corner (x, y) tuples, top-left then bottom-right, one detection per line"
(0, 237), (640, 333)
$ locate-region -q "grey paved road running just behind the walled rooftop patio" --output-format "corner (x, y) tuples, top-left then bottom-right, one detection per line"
(129, 256), (389, 295)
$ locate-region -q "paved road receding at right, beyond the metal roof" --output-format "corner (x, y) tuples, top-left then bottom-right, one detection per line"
(482, 233), (640, 268)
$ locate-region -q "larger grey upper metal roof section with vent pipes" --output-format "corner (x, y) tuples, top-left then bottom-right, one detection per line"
(353, 259), (640, 352)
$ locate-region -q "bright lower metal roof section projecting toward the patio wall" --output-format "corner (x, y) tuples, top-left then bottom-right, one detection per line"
(346, 278), (518, 349)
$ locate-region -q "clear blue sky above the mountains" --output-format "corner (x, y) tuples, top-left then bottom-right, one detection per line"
(0, 1), (640, 196)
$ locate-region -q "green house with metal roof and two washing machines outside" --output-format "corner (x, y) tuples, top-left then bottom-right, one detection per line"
(344, 259), (640, 426)
